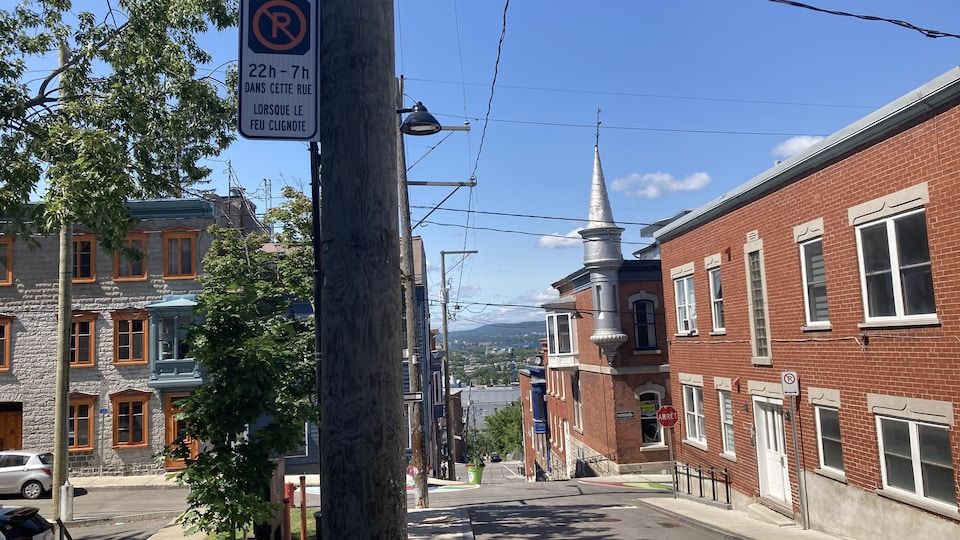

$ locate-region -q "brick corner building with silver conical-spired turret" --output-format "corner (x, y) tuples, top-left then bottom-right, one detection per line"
(525, 144), (671, 479)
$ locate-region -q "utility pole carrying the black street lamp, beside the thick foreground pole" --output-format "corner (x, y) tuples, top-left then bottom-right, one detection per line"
(395, 77), (430, 508)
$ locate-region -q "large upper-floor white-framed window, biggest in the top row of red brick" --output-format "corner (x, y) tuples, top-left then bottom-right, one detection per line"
(857, 210), (936, 321)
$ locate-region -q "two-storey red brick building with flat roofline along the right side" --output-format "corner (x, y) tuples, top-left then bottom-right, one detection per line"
(654, 69), (960, 539)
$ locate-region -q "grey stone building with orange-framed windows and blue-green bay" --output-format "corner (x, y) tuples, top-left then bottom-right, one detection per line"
(0, 193), (262, 475)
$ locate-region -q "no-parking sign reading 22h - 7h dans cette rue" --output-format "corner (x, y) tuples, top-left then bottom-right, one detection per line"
(239, 0), (320, 141)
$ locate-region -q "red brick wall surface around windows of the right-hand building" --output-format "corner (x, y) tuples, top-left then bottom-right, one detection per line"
(661, 98), (960, 516)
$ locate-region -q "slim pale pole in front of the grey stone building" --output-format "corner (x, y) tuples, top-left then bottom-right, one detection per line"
(51, 41), (73, 520)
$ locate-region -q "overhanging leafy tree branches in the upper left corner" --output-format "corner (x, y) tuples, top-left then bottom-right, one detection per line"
(0, 0), (236, 244)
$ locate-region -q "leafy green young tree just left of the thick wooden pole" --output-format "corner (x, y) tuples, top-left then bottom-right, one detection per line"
(173, 192), (319, 533)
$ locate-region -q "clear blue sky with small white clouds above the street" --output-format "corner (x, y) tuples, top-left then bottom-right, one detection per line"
(31, 0), (960, 328)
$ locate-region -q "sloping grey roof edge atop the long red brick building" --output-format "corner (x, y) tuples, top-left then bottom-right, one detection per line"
(653, 67), (960, 242)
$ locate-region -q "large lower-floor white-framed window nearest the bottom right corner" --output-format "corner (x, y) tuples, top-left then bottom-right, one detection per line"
(877, 416), (957, 507)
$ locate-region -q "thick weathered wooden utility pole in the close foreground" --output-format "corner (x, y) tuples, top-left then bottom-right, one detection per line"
(318, 0), (407, 539)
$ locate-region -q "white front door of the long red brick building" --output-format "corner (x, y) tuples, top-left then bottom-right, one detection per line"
(754, 398), (790, 506)
